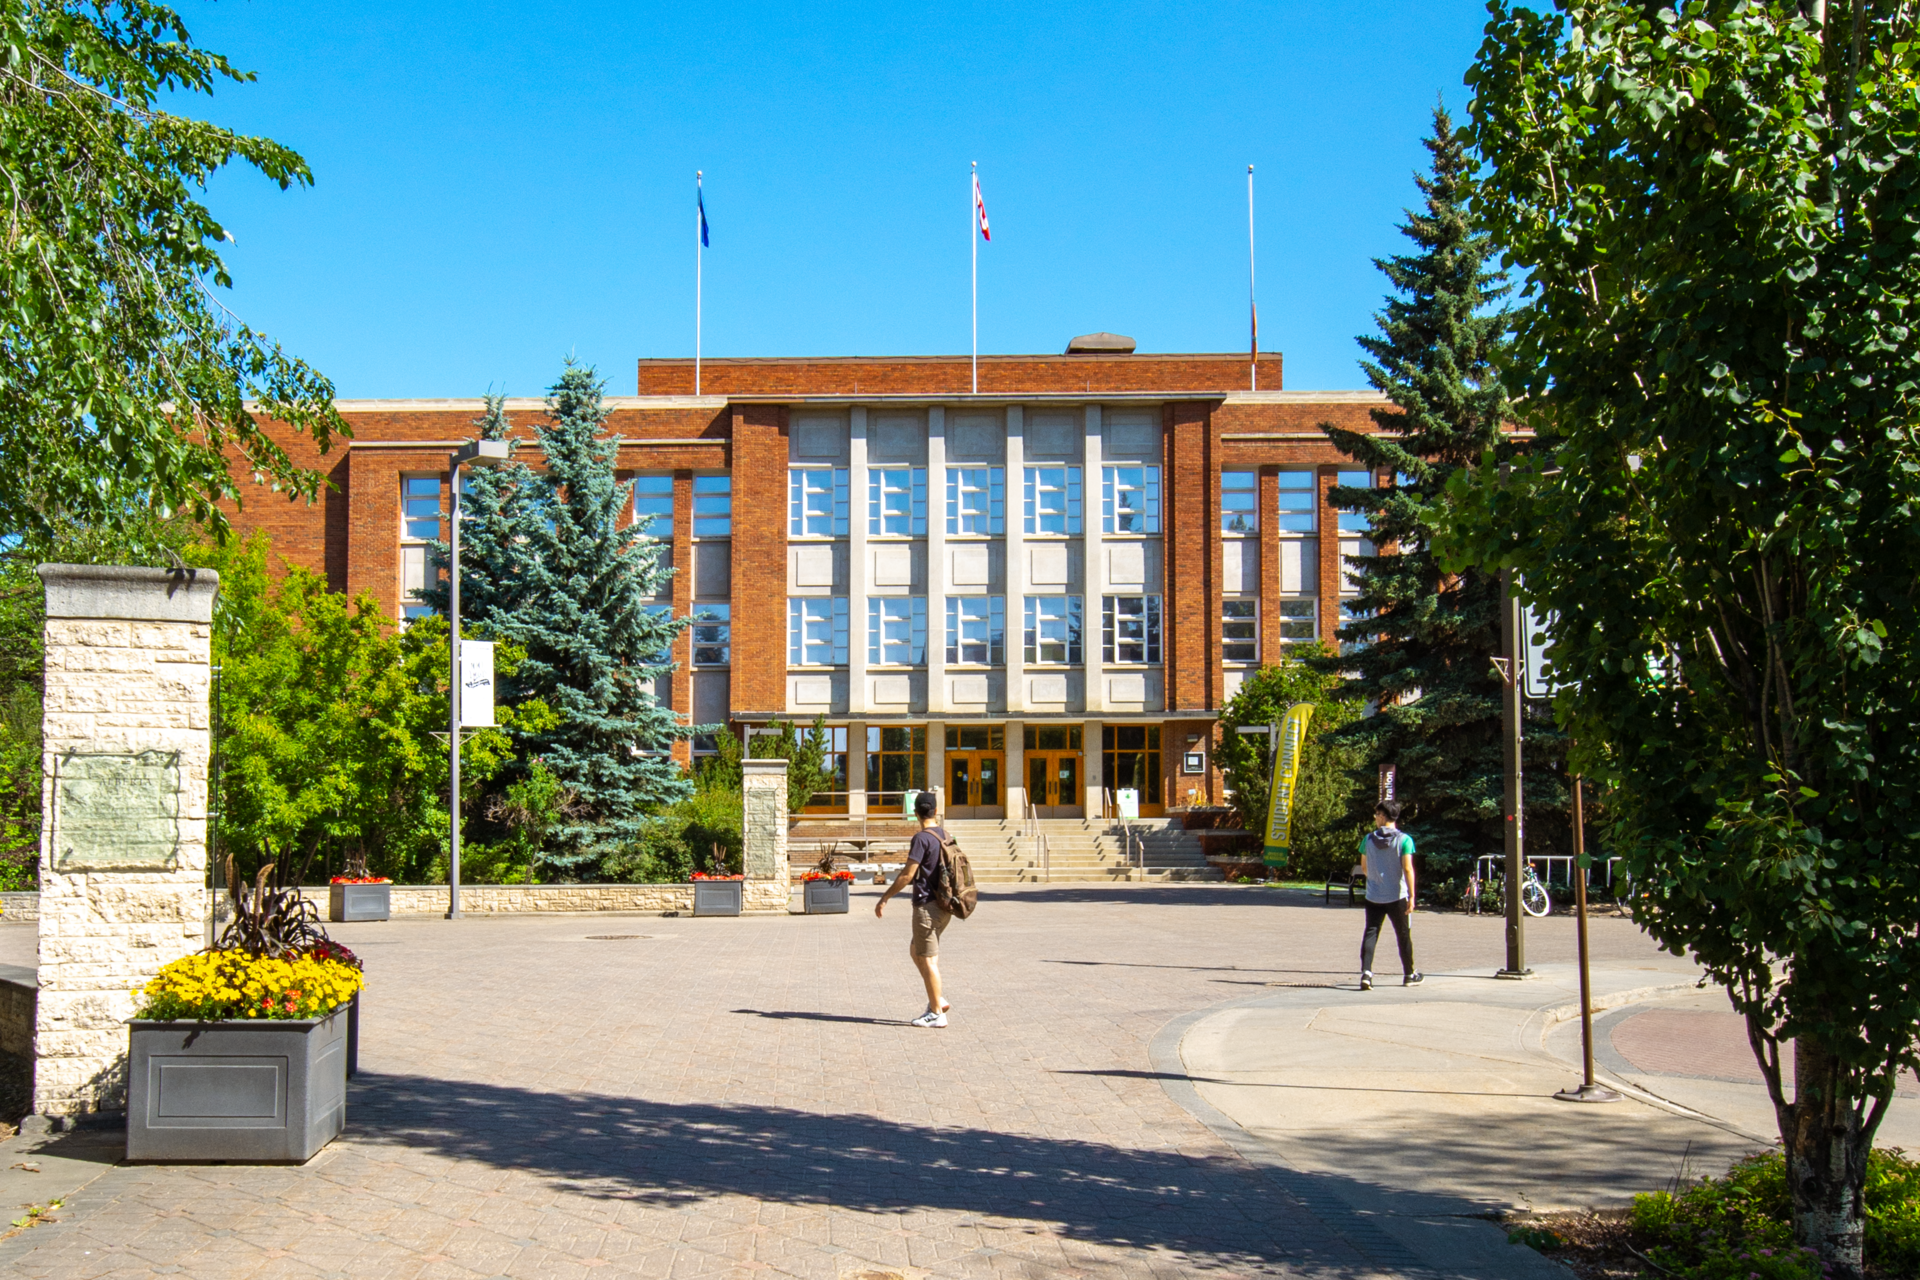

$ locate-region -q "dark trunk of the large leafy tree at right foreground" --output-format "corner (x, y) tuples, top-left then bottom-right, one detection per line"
(1780, 1038), (1874, 1280)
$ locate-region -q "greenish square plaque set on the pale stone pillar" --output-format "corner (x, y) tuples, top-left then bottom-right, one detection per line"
(52, 750), (180, 871)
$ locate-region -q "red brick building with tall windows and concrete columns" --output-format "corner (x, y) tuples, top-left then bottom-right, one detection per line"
(224, 339), (1388, 818)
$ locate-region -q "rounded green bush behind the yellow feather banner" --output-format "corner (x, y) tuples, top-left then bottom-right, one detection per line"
(1213, 662), (1373, 877)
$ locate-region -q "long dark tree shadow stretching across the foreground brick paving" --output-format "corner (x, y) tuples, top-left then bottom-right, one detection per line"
(348, 1073), (1369, 1276)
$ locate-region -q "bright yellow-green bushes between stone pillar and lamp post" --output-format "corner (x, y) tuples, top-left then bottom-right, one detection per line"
(190, 535), (551, 883)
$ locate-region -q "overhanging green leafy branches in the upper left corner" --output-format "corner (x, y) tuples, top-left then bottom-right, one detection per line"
(0, 0), (349, 535)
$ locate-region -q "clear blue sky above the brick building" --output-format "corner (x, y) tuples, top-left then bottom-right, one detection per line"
(177, 0), (1484, 397)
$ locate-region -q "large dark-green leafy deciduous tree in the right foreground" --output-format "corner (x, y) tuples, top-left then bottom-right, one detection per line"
(1440, 0), (1920, 1274)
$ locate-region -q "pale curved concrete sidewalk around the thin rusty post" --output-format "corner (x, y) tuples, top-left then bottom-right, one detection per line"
(1156, 956), (1920, 1276)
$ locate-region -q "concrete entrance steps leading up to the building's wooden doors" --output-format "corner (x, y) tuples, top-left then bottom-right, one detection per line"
(947, 818), (1221, 885)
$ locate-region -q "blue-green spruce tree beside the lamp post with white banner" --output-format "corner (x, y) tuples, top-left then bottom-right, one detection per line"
(428, 361), (691, 879)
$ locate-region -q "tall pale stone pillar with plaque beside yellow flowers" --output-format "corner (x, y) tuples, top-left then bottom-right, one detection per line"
(33, 564), (219, 1115)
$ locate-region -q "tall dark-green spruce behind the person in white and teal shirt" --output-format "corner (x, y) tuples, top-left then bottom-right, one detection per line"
(1315, 107), (1565, 883)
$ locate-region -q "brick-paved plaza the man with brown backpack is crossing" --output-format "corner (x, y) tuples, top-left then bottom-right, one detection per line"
(0, 887), (1712, 1280)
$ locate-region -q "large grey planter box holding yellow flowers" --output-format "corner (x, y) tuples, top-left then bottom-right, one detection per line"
(127, 1007), (348, 1165)
